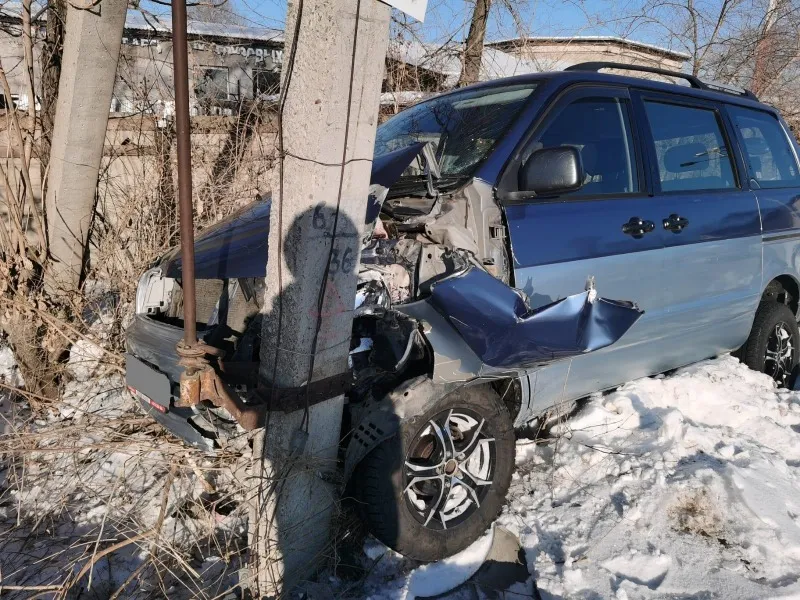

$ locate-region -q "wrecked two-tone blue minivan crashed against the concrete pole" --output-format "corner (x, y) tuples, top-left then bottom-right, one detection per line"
(128, 63), (800, 560)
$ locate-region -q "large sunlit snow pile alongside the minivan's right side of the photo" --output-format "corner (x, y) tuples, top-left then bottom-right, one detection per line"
(499, 356), (800, 600)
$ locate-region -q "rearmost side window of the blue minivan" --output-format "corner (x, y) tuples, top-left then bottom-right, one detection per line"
(728, 106), (800, 188)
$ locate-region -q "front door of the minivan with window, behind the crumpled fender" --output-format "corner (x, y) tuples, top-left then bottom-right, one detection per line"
(503, 86), (666, 414)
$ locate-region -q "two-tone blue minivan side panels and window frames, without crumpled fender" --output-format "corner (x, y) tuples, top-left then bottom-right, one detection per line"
(481, 73), (800, 423)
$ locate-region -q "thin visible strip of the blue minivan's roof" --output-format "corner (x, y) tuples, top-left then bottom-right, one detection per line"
(434, 67), (778, 114)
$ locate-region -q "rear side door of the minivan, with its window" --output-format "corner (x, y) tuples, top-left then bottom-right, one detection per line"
(634, 92), (761, 367)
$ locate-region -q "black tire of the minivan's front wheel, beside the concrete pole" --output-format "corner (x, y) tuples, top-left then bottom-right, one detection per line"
(353, 385), (515, 561)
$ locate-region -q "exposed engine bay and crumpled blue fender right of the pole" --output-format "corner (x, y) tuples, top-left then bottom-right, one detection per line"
(351, 148), (642, 406)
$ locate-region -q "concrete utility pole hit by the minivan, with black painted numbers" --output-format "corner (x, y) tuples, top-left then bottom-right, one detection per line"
(251, 0), (390, 597)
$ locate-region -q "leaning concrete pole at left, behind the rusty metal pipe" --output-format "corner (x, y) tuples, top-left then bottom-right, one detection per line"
(44, 0), (128, 293)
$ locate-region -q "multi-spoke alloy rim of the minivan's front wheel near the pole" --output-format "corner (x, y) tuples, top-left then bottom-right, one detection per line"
(403, 409), (496, 529)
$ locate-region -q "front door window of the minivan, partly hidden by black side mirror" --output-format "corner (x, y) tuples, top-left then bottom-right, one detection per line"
(531, 97), (639, 196)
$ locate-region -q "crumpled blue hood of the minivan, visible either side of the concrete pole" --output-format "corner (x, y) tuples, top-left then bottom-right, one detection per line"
(161, 143), (425, 279)
